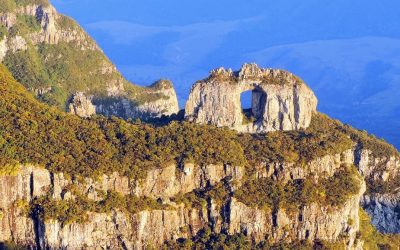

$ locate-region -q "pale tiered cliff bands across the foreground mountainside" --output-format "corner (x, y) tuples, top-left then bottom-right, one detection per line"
(0, 147), (376, 249)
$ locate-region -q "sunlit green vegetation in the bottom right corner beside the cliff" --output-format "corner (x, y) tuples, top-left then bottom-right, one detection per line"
(358, 209), (400, 250)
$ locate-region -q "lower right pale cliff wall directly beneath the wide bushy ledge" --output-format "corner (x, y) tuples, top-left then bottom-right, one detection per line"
(228, 184), (365, 248)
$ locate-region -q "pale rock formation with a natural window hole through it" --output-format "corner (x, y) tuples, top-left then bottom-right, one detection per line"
(185, 64), (318, 133)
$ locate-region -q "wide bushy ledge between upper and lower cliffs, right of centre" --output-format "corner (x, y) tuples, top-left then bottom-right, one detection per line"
(234, 166), (361, 211)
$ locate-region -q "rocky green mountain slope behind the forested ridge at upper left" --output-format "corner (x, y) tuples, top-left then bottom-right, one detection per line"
(0, 0), (179, 119)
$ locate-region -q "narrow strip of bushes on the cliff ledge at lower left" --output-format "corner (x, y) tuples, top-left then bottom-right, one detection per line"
(28, 191), (167, 226)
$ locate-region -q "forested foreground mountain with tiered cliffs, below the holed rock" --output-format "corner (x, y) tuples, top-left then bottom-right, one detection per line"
(0, 63), (400, 249)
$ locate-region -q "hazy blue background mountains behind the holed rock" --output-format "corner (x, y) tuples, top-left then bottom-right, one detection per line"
(52, 0), (400, 147)
